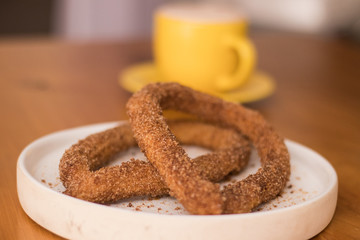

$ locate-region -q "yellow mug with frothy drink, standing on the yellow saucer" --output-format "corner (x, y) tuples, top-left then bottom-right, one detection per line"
(153, 4), (256, 93)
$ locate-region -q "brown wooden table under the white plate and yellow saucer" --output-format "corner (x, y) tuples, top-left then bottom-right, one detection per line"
(0, 33), (360, 240)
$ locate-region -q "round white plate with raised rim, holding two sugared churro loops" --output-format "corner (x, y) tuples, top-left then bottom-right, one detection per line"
(17, 122), (338, 240)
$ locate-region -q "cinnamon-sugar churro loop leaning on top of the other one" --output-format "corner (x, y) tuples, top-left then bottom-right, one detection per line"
(127, 83), (290, 214)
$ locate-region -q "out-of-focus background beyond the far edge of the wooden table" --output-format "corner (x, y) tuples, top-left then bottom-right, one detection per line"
(0, 0), (360, 41)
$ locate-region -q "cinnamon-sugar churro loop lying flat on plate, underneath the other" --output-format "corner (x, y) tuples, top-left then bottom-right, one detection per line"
(59, 121), (250, 203)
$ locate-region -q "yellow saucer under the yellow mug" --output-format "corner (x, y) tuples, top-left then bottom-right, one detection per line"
(119, 62), (275, 103)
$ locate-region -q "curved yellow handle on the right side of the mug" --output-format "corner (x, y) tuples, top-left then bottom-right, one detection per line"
(216, 36), (256, 91)
